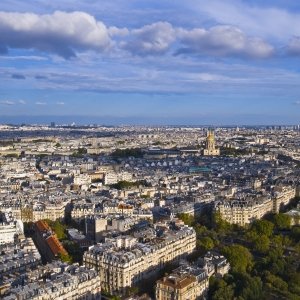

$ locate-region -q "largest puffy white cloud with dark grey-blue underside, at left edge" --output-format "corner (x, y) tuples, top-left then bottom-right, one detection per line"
(0, 11), (111, 58)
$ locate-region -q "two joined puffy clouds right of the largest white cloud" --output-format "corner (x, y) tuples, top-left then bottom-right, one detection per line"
(121, 22), (274, 58)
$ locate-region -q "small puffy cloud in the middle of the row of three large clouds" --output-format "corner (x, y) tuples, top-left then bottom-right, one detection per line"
(121, 22), (176, 56)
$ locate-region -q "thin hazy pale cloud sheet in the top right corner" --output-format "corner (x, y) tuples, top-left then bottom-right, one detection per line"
(190, 0), (300, 42)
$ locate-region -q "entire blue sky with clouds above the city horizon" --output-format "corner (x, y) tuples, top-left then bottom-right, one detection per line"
(0, 0), (300, 126)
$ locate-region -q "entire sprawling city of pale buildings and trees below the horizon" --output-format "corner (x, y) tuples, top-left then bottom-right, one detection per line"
(0, 122), (300, 300)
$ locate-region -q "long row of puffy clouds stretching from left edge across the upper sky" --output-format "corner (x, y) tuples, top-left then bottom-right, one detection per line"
(0, 11), (274, 59)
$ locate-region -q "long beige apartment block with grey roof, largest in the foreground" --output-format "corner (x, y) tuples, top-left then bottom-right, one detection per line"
(83, 225), (196, 294)
